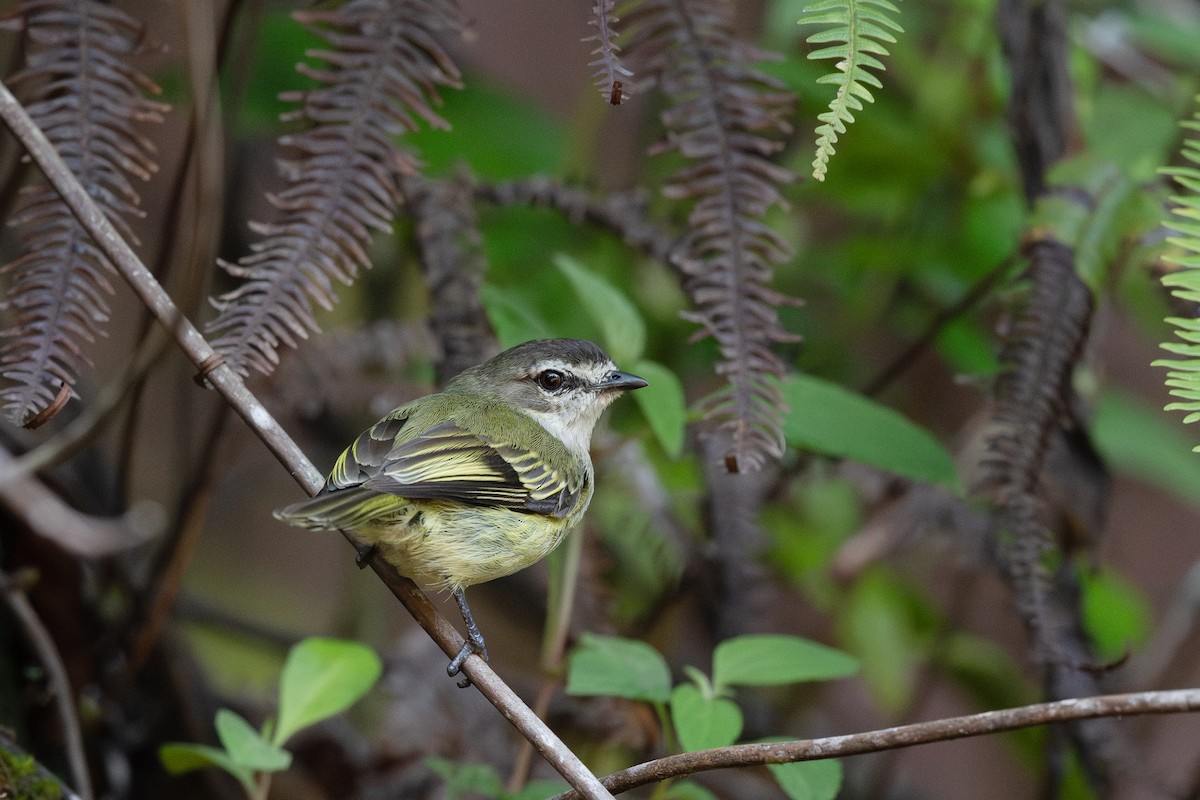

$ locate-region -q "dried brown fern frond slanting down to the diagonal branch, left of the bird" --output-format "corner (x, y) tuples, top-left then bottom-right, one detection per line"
(209, 0), (461, 373)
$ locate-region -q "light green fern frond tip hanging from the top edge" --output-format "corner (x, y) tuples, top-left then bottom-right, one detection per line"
(798, 0), (904, 181)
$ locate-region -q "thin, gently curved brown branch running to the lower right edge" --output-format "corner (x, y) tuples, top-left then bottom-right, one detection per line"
(552, 688), (1200, 800)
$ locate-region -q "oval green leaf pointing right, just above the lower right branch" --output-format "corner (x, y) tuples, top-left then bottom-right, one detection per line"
(713, 633), (858, 693)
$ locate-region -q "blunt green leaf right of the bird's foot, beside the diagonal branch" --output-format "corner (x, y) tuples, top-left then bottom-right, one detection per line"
(566, 633), (671, 703)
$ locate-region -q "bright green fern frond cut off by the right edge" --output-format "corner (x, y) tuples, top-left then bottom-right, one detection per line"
(1154, 96), (1200, 443)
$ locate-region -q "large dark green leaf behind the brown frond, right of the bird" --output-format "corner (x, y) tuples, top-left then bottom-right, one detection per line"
(784, 375), (958, 491)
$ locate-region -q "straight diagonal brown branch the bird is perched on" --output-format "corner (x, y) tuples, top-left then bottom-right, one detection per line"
(0, 82), (610, 799)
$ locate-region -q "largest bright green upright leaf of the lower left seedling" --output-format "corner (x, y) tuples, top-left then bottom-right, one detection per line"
(271, 637), (383, 745)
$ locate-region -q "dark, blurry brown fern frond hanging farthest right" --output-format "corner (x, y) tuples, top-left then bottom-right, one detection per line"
(974, 241), (1092, 662)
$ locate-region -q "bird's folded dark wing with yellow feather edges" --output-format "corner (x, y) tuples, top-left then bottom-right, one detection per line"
(362, 421), (587, 517)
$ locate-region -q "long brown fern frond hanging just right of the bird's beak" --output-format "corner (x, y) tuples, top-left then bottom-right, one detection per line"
(628, 0), (794, 470)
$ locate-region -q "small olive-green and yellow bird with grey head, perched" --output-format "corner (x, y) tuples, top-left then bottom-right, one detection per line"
(275, 339), (647, 686)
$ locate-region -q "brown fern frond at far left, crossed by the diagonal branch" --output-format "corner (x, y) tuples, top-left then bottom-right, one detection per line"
(0, 0), (167, 423)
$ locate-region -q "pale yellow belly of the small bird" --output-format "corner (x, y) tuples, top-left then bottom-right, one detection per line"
(356, 500), (575, 591)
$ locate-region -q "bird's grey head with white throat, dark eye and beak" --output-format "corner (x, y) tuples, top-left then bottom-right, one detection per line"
(448, 339), (647, 452)
